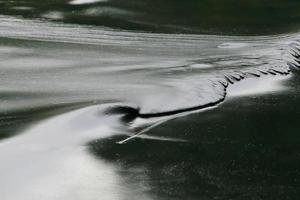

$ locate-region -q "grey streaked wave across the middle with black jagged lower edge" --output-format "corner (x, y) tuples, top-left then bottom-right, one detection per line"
(0, 16), (300, 132)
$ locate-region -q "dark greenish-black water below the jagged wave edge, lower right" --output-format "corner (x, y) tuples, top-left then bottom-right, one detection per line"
(89, 74), (300, 200)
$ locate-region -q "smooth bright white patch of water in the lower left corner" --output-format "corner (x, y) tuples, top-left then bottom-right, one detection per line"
(0, 106), (148, 200)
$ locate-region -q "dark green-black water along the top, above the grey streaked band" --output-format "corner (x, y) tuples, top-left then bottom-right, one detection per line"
(0, 0), (300, 35)
